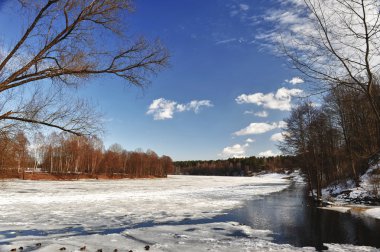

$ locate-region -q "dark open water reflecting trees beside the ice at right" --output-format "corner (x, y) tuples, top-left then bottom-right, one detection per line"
(230, 184), (380, 248)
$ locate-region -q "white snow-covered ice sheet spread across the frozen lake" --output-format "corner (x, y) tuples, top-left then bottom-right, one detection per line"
(0, 174), (377, 251)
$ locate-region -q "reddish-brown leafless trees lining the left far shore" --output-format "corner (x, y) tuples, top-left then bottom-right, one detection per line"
(0, 131), (174, 178)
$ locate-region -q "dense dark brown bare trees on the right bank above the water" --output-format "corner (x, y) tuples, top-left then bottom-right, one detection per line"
(281, 84), (380, 197)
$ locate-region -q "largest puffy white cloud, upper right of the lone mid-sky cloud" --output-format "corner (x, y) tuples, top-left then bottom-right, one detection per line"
(235, 87), (303, 111)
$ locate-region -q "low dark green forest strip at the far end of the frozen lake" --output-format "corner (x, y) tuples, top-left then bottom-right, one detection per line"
(174, 156), (298, 176)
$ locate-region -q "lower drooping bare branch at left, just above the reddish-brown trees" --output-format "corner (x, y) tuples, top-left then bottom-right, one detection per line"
(0, 85), (102, 135)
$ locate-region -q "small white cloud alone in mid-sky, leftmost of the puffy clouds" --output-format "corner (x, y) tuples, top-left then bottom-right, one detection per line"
(147, 98), (213, 120)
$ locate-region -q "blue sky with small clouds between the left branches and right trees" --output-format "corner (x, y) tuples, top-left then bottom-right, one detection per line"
(0, 0), (305, 160)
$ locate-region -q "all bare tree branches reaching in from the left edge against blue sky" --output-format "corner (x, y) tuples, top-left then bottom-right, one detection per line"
(0, 0), (168, 134)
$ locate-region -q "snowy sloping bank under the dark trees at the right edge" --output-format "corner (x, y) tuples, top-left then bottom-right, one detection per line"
(322, 164), (380, 219)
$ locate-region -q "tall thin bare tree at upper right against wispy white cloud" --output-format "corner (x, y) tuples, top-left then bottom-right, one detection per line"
(272, 0), (380, 122)
